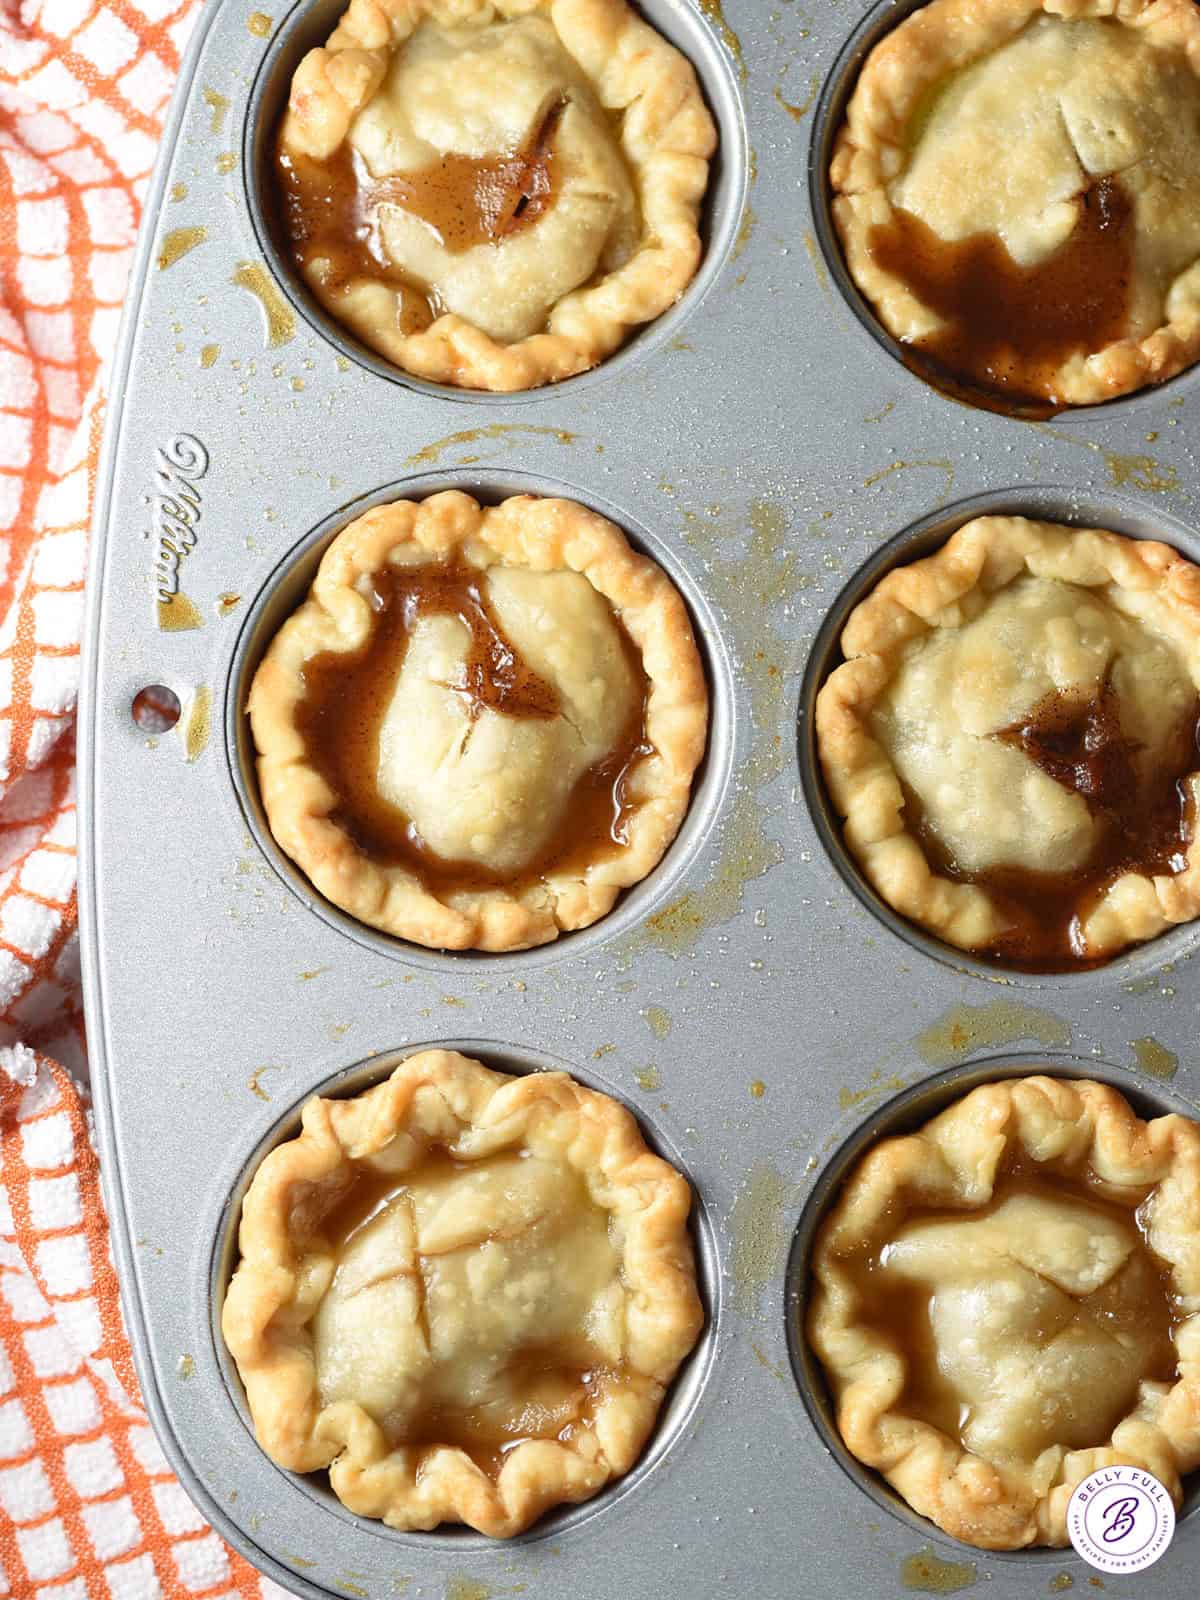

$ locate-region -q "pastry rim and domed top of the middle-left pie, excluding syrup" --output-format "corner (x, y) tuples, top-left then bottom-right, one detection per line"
(248, 491), (707, 950)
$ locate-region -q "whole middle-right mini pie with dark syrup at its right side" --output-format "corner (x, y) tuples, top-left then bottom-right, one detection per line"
(816, 517), (1200, 970)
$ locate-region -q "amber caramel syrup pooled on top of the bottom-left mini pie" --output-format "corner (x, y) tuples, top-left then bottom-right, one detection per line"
(321, 1146), (629, 1478)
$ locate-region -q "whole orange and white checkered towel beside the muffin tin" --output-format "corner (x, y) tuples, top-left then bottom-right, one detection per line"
(0, 0), (283, 1600)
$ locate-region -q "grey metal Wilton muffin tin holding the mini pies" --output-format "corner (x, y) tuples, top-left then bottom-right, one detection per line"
(80, 0), (1200, 1600)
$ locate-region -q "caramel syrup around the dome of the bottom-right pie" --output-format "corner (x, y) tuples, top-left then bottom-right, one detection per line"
(843, 1154), (1184, 1448)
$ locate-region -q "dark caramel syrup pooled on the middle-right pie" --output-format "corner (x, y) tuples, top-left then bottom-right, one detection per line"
(904, 680), (1200, 973)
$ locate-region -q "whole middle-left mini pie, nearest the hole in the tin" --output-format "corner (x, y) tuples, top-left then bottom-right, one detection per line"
(248, 491), (707, 950)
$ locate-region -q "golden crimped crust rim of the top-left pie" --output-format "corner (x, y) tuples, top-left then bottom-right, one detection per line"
(282, 0), (717, 390)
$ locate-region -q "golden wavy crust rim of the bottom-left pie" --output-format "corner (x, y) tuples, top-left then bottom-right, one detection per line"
(222, 1050), (704, 1539)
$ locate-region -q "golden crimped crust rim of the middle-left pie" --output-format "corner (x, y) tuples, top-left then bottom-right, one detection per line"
(248, 491), (709, 950)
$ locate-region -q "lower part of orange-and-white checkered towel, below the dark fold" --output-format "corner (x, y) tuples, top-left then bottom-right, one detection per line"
(0, 1045), (291, 1600)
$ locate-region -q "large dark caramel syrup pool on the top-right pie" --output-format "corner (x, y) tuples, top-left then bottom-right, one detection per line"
(869, 178), (1134, 418)
